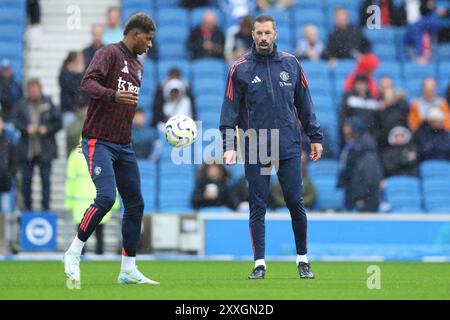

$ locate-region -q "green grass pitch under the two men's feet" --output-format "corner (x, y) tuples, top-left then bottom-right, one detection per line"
(0, 261), (450, 300)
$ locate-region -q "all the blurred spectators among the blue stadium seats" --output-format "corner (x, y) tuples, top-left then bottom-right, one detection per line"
(0, 0), (450, 215)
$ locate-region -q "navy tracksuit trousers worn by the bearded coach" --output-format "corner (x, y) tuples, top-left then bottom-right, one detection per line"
(245, 156), (307, 260)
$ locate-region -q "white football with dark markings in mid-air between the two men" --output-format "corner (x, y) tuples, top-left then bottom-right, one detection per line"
(164, 115), (197, 148)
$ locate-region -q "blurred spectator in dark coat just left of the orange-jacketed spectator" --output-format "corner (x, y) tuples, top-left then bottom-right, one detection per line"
(375, 77), (409, 151)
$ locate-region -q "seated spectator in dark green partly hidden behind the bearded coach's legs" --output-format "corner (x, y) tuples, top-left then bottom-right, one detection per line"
(268, 152), (316, 209)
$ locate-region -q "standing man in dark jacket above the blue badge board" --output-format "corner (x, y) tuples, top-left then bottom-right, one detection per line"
(15, 78), (62, 211)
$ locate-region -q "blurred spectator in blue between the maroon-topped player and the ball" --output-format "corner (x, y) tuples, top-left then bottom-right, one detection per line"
(131, 109), (161, 160)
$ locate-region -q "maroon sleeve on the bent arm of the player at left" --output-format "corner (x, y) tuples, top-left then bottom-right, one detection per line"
(81, 46), (116, 101)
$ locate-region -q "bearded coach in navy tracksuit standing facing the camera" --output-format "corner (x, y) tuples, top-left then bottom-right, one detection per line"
(220, 15), (323, 279)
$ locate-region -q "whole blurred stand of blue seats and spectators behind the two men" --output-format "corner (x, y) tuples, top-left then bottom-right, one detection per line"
(0, 0), (450, 219)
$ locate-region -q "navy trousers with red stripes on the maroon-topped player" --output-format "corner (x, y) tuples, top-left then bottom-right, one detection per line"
(78, 138), (144, 256)
